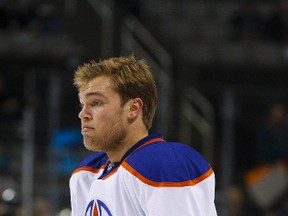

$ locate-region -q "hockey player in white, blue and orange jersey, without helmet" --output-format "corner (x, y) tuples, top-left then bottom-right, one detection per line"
(70, 56), (217, 216)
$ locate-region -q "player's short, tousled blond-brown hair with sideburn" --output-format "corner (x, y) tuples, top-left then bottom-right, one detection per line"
(74, 56), (157, 129)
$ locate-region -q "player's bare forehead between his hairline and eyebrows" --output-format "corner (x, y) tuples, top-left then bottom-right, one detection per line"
(78, 76), (117, 98)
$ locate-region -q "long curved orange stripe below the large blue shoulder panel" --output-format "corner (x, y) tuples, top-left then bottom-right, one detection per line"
(122, 162), (214, 187)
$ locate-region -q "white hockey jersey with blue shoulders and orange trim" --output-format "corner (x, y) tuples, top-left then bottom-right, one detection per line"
(70, 134), (217, 216)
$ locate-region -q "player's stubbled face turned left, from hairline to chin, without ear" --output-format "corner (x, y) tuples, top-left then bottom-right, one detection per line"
(79, 76), (129, 153)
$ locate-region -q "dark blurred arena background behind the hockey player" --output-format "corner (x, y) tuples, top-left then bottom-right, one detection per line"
(0, 0), (288, 216)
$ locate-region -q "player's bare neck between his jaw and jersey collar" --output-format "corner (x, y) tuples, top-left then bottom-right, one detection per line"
(106, 131), (148, 163)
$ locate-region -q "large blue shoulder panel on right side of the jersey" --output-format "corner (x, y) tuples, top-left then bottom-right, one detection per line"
(126, 142), (210, 182)
